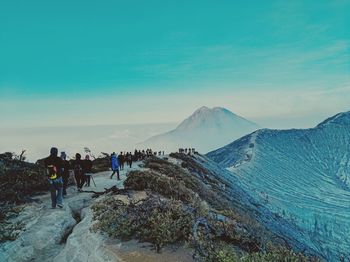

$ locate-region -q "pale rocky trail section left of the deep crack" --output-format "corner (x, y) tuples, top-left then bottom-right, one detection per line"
(0, 167), (132, 261)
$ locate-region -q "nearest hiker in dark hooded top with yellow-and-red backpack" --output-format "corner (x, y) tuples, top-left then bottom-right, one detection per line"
(44, 147), (63, 208)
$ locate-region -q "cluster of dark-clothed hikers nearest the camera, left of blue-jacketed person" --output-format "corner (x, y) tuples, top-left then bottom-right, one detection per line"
(44, 147), (92, 208)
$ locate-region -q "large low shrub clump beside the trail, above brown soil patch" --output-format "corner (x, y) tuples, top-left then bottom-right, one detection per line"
(92, 196), (193, 252)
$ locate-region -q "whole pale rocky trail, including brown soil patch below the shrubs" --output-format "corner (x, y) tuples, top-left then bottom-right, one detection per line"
(0, 163), (193, 262)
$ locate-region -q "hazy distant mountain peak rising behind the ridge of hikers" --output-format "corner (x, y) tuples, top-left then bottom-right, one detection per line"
(139, 106), (260, 152)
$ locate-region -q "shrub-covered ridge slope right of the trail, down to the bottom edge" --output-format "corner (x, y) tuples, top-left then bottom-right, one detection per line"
(92, 157), (320, 262)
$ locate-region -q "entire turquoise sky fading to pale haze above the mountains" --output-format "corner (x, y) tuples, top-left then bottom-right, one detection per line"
(0, 0), (350, 127)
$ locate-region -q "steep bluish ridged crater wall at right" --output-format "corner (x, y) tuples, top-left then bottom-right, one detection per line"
(208, 112), (350, 261)
